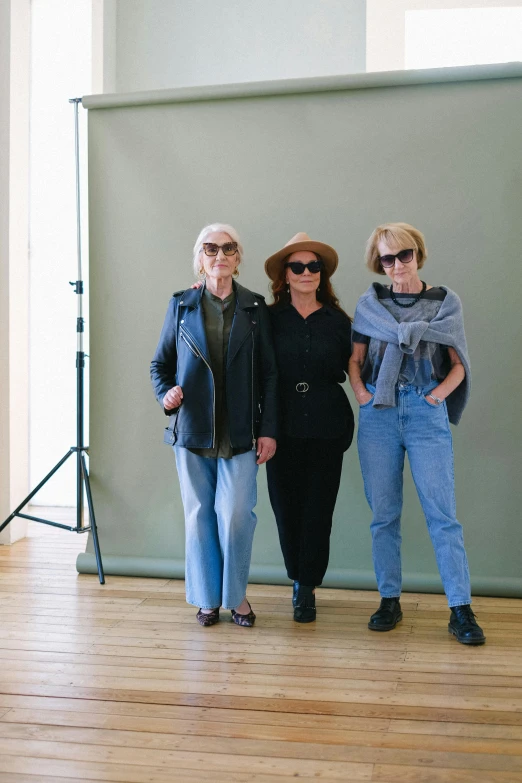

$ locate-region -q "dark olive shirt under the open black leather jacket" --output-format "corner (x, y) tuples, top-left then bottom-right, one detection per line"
(189, 286), (248, 459)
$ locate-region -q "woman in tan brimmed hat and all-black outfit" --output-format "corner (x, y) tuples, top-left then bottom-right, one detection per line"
(265, 233), (354, 623)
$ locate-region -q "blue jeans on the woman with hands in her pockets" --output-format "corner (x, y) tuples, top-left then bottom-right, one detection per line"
(357, 382), (471, 606)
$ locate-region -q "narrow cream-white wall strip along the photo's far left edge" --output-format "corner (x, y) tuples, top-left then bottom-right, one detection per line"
(0, 0), (30, 544)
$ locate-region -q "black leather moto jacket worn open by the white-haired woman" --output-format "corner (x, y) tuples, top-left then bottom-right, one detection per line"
(150, 282), (277, 448)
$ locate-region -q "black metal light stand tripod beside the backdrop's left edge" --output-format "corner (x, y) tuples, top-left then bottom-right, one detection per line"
(0, 98), (105, 584)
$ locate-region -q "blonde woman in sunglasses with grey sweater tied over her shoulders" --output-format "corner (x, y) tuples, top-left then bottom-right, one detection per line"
(349, 223), (486, 644)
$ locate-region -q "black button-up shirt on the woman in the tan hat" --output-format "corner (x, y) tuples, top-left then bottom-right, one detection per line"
(269, 304), (353, 448)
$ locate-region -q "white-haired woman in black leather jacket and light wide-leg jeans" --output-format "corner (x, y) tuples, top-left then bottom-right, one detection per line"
(151, 223), (277, 627)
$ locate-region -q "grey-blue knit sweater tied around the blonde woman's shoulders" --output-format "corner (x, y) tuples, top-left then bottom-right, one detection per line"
(352, 285), (471, 424)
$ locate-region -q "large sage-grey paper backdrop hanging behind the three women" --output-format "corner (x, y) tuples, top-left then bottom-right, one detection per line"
(78, 69), (522, 595)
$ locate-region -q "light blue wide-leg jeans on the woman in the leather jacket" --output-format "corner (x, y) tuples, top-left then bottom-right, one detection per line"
(174, 446), (258, 609)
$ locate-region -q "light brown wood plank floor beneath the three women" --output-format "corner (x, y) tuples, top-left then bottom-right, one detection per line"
(0, 509), (522, 783)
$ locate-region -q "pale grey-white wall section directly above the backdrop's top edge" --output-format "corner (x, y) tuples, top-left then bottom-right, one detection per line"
(100, 0), (366, 92)
